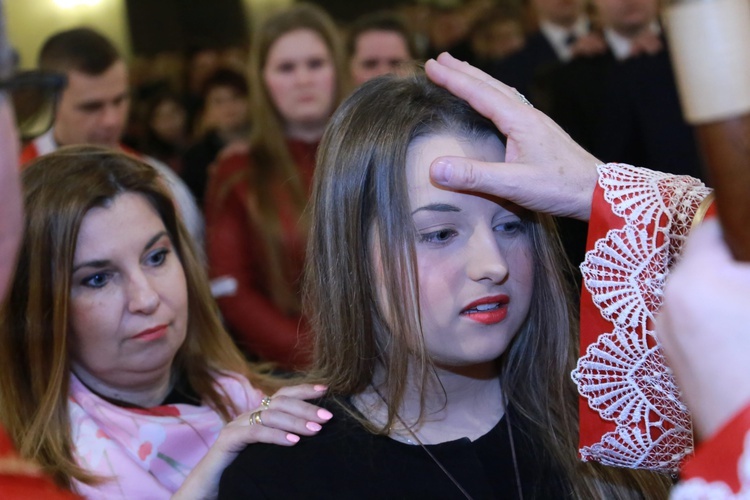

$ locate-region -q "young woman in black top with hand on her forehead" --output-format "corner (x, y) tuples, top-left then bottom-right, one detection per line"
(219, 75), (670, 498)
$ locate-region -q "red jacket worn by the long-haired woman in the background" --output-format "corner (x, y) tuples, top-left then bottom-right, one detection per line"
(205, 140), (318, 369)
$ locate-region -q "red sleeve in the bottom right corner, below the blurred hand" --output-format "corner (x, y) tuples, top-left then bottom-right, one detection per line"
(680, 405), (750, 493)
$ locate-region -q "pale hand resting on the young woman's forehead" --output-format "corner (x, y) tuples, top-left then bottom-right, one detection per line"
(425, 53), (601, 220)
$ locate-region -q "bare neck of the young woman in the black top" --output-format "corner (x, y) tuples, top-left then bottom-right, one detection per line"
(355, 367), (505, 444)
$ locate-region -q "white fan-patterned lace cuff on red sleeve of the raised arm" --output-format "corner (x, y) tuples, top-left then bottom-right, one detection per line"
(571, 164), (711, 471)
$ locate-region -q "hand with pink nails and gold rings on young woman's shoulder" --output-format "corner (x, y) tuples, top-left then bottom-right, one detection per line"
(172, 384), (331, 500)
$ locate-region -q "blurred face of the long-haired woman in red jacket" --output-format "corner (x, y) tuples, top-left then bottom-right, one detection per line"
(263, 29), (336, 130)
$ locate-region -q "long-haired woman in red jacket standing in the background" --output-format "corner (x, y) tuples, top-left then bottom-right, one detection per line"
(205, 4), (345, 370)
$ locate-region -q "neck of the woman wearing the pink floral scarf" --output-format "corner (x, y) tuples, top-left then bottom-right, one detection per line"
(73, 364), (173, 408)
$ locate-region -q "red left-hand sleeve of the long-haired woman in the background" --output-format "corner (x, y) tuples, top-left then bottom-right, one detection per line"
(206, 155), (307, 369)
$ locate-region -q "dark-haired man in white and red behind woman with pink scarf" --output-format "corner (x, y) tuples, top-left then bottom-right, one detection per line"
(21, 28), (204, 247)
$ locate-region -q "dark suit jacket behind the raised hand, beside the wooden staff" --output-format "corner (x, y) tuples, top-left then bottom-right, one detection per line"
(537, 37), (703, 183)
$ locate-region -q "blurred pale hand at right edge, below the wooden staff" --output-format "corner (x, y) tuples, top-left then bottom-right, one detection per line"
(656, 220), (750, 439)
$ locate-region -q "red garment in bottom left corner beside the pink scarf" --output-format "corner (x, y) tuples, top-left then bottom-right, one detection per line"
(0, 429), (79, 500)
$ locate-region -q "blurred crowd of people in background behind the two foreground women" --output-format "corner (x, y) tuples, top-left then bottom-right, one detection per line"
(6, 0), (704, 369)
